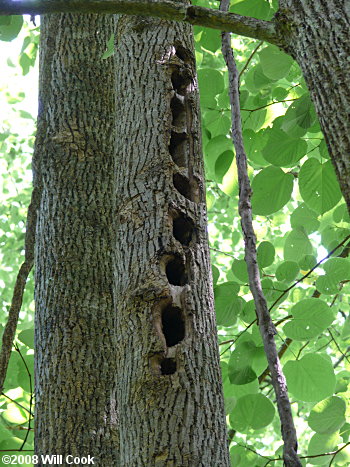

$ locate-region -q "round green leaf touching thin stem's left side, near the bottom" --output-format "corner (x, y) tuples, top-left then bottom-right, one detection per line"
(230, 394), (275, 432)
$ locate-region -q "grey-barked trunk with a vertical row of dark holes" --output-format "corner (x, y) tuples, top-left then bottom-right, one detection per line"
(116, 11), (230, 467)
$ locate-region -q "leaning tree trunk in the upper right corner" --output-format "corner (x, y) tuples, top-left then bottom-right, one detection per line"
(277, 0), (350, 212)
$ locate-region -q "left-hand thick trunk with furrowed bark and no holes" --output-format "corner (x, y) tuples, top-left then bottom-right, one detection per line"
(33, 14), (118, 466)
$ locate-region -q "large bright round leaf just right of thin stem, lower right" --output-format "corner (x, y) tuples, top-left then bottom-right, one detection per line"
(283, 353), (336, 402)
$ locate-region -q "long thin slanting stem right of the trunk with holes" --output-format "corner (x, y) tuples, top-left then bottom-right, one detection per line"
(220, 0), (301, 467)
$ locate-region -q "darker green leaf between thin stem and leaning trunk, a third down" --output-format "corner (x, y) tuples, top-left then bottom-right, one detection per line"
(262, 128), (307, 167)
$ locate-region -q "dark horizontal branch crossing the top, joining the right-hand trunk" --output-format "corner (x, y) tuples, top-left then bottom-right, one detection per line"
(0, 0), (282, 46)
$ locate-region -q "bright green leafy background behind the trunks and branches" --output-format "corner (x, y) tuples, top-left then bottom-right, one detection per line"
(0, 0), (350, 467)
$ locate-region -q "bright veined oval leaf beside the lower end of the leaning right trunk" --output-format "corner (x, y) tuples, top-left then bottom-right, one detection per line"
(299, 157), (341, 214)
